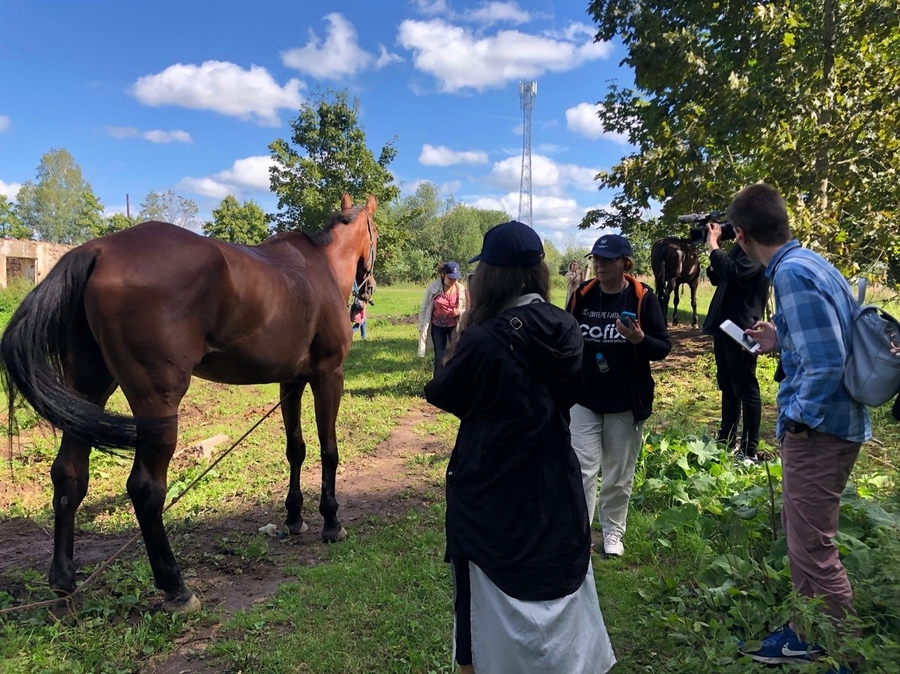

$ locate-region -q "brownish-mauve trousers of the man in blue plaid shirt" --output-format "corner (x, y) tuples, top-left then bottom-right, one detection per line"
(781, 431), (860, 620)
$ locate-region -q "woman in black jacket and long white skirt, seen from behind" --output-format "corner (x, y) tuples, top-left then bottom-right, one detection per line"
(425, 222), (615, 674)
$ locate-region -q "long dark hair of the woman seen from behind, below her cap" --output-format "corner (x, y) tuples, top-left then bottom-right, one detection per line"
(459, 260), (550, 332)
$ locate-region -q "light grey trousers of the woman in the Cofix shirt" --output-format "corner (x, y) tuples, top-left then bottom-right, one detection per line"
(569, 405), (644, 538)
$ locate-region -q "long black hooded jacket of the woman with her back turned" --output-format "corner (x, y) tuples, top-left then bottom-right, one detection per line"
(425, 302), (591, 601)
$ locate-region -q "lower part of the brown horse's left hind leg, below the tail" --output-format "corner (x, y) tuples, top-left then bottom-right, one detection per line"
(48, 433), (91, 596)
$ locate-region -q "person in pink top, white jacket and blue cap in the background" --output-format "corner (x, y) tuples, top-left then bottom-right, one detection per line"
(419, 260), (466, 372)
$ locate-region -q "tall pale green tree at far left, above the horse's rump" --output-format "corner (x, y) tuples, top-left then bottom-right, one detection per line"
(16, 149), (103, 244)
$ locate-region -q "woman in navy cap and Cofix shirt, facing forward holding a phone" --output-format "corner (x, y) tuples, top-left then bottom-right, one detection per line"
(569, 234), (672, 557)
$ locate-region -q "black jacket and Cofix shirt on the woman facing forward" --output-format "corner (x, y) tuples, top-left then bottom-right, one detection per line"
(570, 277), (672, 423)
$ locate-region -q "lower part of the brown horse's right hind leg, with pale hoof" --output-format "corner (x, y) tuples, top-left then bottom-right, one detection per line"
(127, 412), (200, 613)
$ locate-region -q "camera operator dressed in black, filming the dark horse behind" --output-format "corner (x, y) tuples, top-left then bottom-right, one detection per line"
(703, 222), (769, 462)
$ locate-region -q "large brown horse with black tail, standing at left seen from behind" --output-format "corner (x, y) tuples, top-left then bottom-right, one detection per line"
(0, 194), (378, 612)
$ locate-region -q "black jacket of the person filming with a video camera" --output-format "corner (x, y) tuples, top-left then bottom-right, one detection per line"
(703, 244), (769, 335)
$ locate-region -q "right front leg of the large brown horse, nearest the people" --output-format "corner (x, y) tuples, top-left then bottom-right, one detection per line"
(312, 364), (347, 543)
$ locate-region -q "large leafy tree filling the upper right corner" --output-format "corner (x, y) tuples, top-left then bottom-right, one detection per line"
(582, 0), (900, 280)
